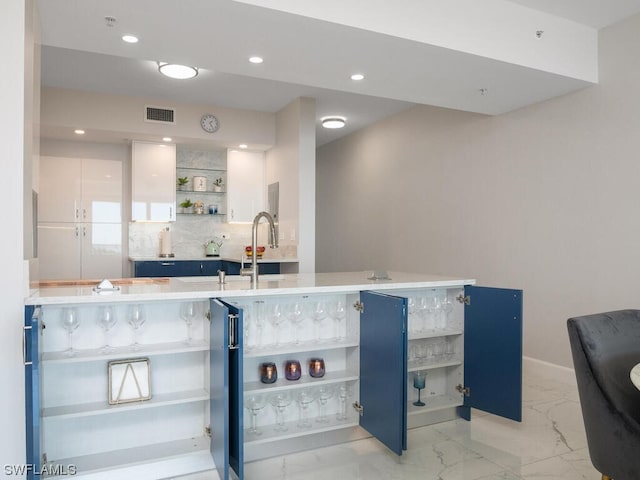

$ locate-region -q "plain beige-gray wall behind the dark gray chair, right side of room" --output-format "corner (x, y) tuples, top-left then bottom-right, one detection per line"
(316, 16), (640, 366)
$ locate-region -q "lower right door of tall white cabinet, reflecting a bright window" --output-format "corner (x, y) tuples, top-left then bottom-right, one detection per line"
(81, 223), (122, 279)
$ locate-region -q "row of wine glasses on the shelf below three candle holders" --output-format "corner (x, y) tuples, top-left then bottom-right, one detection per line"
(244, 384), (353, 435)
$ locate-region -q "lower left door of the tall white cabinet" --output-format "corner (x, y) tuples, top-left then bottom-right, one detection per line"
(38, 222), (82, 280)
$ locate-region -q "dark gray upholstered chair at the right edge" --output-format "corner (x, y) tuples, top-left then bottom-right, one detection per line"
(567, 310), (640, 480)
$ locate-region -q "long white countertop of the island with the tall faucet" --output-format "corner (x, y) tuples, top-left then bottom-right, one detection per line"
(25, 271), (475, 305)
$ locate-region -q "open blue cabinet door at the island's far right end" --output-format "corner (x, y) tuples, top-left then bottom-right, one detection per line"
(461, 286), (522, 422)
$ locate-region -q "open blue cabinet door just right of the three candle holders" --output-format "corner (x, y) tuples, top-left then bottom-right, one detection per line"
(360, 292), (407, 455)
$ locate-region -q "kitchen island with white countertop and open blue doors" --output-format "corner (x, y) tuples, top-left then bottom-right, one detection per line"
(25, 272), (522, 479)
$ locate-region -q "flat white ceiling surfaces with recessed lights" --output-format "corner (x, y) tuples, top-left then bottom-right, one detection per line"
(38, 0), (640, 145)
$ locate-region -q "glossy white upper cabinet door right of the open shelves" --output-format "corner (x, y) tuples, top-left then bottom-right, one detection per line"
(227, 150), (265, 223)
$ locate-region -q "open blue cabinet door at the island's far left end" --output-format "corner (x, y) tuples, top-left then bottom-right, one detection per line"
(22, 306), (42, 480)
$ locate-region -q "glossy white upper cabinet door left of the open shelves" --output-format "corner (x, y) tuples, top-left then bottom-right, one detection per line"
(131, 142), (176, 222)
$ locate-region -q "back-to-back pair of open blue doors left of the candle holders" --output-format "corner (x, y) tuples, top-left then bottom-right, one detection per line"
(209, 299), (244, 480)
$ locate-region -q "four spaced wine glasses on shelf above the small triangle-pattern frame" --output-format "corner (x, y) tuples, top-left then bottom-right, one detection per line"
(60, 302), (200, 357)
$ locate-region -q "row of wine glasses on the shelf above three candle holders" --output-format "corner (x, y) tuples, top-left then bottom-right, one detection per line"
(244, 300), (347, 350)
